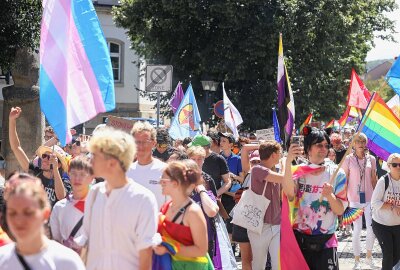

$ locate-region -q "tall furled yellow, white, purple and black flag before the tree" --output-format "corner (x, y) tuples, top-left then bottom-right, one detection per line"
(278, 34), (295, 149)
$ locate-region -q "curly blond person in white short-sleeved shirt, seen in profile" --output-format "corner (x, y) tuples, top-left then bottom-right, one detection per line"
(78, 128), (158, 270)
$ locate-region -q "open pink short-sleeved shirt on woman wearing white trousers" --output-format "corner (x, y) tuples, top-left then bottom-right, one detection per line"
(342, 154), (376, 203)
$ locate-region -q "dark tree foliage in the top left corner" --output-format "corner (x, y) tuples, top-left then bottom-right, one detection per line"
(0, 0), (42, 70)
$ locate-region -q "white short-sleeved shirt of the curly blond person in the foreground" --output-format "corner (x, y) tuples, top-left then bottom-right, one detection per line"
(81, 179), (158, 270)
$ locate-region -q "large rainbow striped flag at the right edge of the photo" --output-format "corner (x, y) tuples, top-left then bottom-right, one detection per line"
(361, 93), (400, 160)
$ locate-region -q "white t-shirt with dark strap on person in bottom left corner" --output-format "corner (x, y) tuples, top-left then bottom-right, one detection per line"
(0, 240), (85, 270)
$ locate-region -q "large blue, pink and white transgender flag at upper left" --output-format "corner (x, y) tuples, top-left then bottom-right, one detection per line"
(40, 0), (115, 145)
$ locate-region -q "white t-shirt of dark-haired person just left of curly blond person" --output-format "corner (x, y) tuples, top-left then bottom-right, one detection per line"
(50, 196), (83, 243)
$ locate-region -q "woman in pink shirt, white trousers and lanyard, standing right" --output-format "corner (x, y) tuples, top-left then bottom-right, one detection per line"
(342, 133), (377, 269)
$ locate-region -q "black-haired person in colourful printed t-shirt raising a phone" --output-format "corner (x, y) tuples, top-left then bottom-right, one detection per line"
(282, 127), (347, 270)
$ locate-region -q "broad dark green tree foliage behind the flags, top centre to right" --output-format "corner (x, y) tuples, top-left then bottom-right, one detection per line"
(114, 0), (396, 129)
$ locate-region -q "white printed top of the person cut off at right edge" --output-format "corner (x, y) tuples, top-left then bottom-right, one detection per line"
(371, 176), (400, 226)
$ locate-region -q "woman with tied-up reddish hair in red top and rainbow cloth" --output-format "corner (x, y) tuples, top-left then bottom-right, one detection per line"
(153, 161), (214, 270)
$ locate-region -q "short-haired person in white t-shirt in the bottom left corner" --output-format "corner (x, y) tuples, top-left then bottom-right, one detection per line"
(0, 174), (85, 270)
